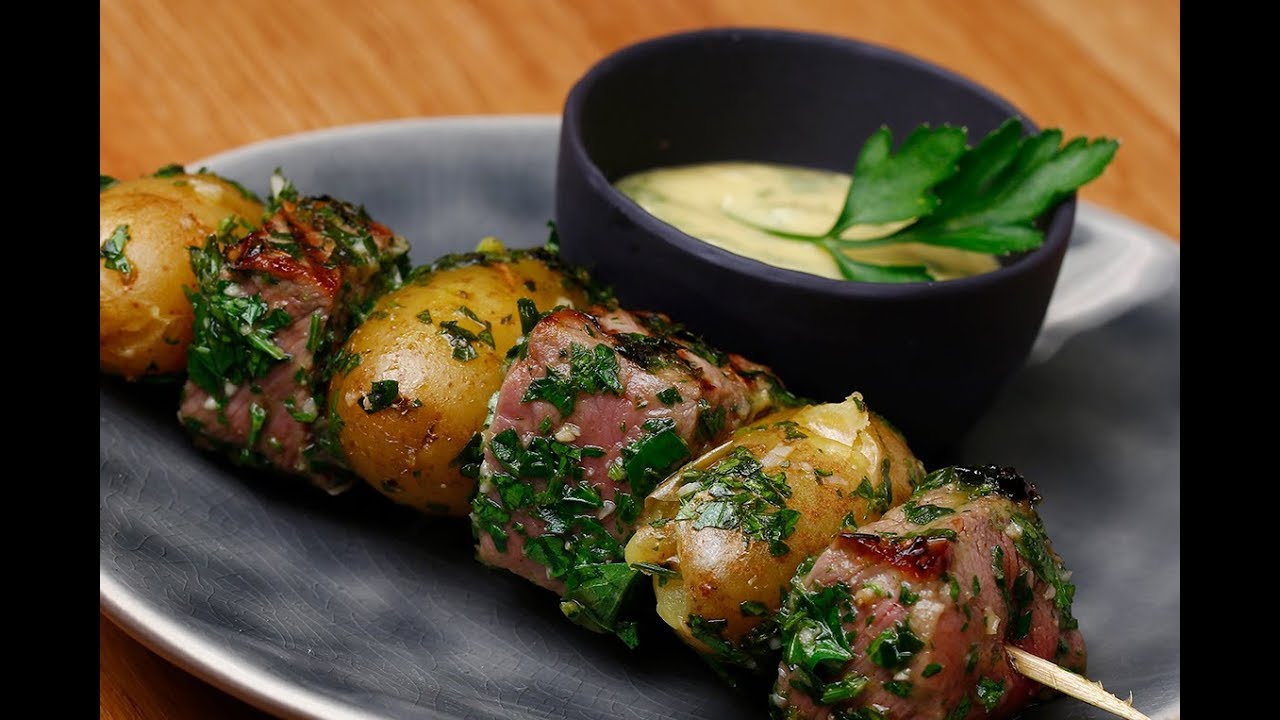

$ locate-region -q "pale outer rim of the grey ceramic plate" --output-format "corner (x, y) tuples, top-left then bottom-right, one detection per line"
(99, 113), (1181, 720)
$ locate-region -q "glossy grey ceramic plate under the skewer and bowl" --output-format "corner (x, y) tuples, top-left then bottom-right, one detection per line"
(100, 117), (1181, 719)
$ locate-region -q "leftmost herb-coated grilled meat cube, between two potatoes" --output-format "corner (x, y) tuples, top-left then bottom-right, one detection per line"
(178, 186), (408, 493)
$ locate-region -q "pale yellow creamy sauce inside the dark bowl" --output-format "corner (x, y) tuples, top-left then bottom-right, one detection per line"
(616, 163), (1000, 281)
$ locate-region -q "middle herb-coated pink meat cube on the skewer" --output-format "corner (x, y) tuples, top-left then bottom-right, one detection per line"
(471, 302), (794, 642)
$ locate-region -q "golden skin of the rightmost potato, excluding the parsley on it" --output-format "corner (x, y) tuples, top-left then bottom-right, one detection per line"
(626, 393), (924, 652)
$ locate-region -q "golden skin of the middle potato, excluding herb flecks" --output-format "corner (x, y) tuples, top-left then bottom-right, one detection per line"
(329, 255), (584, 516)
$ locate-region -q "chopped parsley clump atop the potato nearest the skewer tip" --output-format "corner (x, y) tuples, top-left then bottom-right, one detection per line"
(676, 446), (800, 556)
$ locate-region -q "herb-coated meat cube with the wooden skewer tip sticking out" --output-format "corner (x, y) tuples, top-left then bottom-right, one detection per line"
(772, 468), (1085, 720)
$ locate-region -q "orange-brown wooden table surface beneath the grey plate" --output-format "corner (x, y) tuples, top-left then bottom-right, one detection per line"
(99, 0), (1181, 720)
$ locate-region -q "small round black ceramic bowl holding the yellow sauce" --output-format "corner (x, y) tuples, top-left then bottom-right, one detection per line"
(556, 28), (1075, 461)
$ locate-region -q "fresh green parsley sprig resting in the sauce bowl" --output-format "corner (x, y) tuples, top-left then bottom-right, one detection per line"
(730, 118), (1119, 282)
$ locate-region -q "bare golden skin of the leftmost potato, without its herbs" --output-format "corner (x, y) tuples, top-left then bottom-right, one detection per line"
(99, 174), (262, 379)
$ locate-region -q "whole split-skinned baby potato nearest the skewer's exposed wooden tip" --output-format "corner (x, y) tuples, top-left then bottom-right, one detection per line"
(626, 393), (924, 667)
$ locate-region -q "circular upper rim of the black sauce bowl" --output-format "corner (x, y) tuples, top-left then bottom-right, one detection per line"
(557, 27), (1076, 300)
